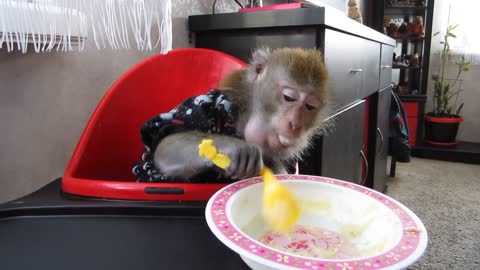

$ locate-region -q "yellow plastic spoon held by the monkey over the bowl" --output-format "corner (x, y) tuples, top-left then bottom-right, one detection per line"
(198, 139), (300, 233)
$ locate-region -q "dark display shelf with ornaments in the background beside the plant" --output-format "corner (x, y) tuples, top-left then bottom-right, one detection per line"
(378, 0), (435, 163)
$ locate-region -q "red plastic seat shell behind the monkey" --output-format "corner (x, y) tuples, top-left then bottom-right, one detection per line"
(62, 48), (246, 200)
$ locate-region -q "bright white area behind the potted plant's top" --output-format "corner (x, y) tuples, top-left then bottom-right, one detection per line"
(432, 0), (480, 65)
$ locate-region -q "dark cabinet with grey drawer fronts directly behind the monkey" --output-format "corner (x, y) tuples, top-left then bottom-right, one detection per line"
(189, 7), (395, 191)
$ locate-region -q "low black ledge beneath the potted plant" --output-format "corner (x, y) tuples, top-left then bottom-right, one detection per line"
(412, 141), (480, 164)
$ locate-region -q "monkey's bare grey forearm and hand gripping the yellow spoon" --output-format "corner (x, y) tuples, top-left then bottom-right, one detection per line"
(154, 131), (262, 179)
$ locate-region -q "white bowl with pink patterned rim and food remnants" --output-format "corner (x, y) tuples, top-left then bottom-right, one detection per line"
(205, 175), (428, 270)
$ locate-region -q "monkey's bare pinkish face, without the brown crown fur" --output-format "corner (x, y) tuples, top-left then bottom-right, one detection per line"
(244, 76), (323, 156)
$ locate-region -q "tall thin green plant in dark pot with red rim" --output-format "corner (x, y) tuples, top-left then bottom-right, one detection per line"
(424, 24), (471, 146)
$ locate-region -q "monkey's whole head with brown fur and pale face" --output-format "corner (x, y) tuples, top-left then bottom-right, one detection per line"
(224, 48), (329, 162)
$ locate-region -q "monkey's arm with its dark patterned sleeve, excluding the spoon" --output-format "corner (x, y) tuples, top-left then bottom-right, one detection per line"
(132, 90), (262, 182)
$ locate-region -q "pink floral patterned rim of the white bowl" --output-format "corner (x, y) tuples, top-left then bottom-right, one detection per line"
(209, 175), (426, 270)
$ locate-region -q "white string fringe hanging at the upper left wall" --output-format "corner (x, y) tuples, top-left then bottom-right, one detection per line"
(0, 0), (172, 53)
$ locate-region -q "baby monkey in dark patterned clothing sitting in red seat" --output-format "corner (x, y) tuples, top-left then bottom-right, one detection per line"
(133, 48), (329, 181)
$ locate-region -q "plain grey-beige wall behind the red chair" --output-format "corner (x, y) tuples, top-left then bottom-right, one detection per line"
(0, 0), (238, 203)
